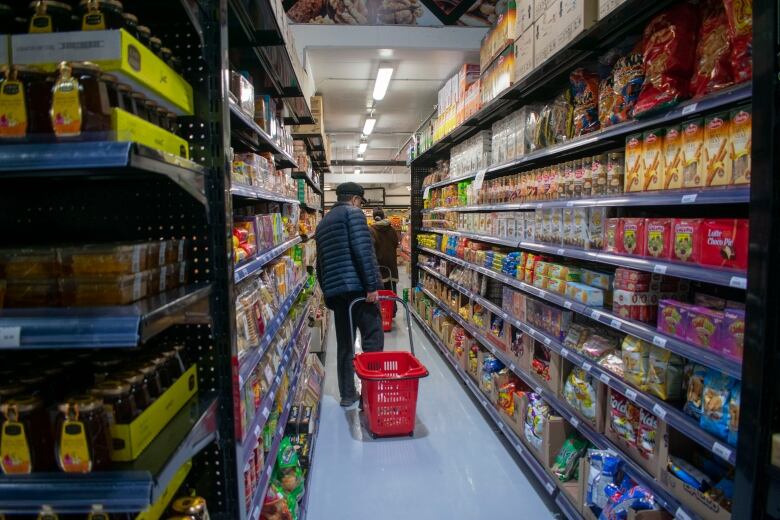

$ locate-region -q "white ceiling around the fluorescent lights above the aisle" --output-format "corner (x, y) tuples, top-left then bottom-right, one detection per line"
(305, 47), (478, 181)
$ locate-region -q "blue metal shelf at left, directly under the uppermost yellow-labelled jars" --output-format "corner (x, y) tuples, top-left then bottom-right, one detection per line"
(0, 141), (206, 205)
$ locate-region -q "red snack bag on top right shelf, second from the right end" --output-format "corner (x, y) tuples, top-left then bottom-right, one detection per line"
(691, 0), (734, 97)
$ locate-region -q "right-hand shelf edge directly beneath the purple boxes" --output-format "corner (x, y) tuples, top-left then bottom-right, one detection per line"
(419, 247), (742, 379)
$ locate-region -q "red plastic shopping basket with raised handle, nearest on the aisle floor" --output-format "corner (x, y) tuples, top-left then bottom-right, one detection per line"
(348, 295), (428, 437)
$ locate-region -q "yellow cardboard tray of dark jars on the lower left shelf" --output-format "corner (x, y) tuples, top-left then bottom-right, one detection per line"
(111, 365), (198, 462)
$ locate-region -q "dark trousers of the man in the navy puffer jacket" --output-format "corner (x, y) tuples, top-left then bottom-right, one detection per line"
(326, 293), (385, 399)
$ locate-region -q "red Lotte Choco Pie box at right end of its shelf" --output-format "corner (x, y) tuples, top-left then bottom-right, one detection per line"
(699, 218), (748, 269)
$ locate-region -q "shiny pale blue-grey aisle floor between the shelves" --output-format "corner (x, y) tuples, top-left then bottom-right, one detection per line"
(307, 278), (562, 520)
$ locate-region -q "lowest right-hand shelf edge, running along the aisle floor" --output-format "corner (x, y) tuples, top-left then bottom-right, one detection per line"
(410, 309), (581, 520)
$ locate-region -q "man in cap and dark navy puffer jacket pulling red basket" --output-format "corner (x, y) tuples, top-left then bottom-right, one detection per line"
(314, 182), (384, 407)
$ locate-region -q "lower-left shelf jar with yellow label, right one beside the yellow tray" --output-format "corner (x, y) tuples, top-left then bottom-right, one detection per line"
(55, 395), (111, 473)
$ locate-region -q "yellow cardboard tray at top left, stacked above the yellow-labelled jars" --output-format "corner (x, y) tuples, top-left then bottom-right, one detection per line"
(11, 29), (194, 116)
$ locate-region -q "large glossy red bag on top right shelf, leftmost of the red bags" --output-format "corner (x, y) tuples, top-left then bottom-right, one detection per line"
(634, 2), (699, 117)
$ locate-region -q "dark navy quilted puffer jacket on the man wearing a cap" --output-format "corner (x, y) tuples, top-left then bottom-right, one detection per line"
(314, 202), (381, 298)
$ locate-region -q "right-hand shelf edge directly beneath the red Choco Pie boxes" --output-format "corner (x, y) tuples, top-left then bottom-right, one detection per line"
(421, 228), (747, 289)
